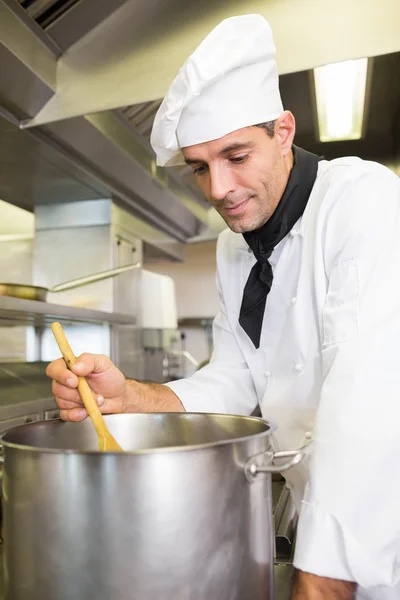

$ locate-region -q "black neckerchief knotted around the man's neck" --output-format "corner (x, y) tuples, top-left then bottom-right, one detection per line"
(239, 146), (319, 348)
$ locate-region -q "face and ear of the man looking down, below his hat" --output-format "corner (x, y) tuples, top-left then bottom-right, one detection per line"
(182, 111), (295, 233)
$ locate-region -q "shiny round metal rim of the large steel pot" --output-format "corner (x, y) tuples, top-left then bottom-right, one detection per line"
(0, 412), (276, 456)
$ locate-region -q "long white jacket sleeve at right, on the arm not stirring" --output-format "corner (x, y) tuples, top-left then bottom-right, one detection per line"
(294, 167), (400, 598)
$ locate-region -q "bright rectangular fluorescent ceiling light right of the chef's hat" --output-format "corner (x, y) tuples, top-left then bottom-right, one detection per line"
(314, 58), (368, 142)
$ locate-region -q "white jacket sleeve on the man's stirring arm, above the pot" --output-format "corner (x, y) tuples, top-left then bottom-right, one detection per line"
(167, 255), (258, 415)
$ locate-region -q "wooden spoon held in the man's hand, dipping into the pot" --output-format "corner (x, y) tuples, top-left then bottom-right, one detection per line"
(51, 323), (123, 452)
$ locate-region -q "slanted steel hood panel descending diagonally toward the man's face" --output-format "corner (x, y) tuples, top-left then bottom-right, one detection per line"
(45, 113), (200, 241)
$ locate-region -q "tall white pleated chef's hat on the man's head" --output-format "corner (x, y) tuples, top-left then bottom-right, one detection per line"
(150, 15), (283, 166)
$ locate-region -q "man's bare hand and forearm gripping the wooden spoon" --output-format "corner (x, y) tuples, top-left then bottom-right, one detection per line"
(46, 353), (184, 421)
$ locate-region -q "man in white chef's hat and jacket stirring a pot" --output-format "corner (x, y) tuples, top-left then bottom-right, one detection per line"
(47, 15), (400, 600)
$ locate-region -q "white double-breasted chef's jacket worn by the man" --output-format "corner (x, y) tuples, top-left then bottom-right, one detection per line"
(168, 157), (400, 600)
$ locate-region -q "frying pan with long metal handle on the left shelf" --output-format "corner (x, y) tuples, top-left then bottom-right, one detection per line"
(0, 263), (140, 302)
